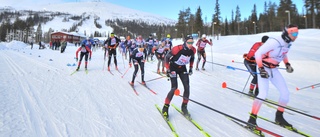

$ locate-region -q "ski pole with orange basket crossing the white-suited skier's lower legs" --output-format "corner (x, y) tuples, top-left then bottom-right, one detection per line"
(222, 82), (320, 120)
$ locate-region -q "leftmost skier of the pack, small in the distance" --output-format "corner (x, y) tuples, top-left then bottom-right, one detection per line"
(76, 44), (92, 71)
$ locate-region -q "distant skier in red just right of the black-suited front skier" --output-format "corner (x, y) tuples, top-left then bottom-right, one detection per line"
(196, 34), (212, 70)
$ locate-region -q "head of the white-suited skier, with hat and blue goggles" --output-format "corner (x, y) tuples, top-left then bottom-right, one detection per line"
(281, 24), (299, 43)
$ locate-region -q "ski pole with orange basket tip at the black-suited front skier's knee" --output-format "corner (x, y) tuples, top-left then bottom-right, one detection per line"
(174, 89), (282, 137)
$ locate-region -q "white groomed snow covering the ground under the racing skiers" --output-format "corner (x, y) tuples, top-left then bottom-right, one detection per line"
(0, 29), (320, 137)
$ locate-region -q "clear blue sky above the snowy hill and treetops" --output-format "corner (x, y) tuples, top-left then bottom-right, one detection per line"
(0, 0), (304, 22)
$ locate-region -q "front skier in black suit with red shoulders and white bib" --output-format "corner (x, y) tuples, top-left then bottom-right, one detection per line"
(162, 36), (196, 118)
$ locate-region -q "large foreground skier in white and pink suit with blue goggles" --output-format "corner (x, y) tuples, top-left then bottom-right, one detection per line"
(248, 24), (298, 131)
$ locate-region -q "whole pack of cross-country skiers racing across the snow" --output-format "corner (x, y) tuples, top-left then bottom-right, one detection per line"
(76, 25), (298, 135)
